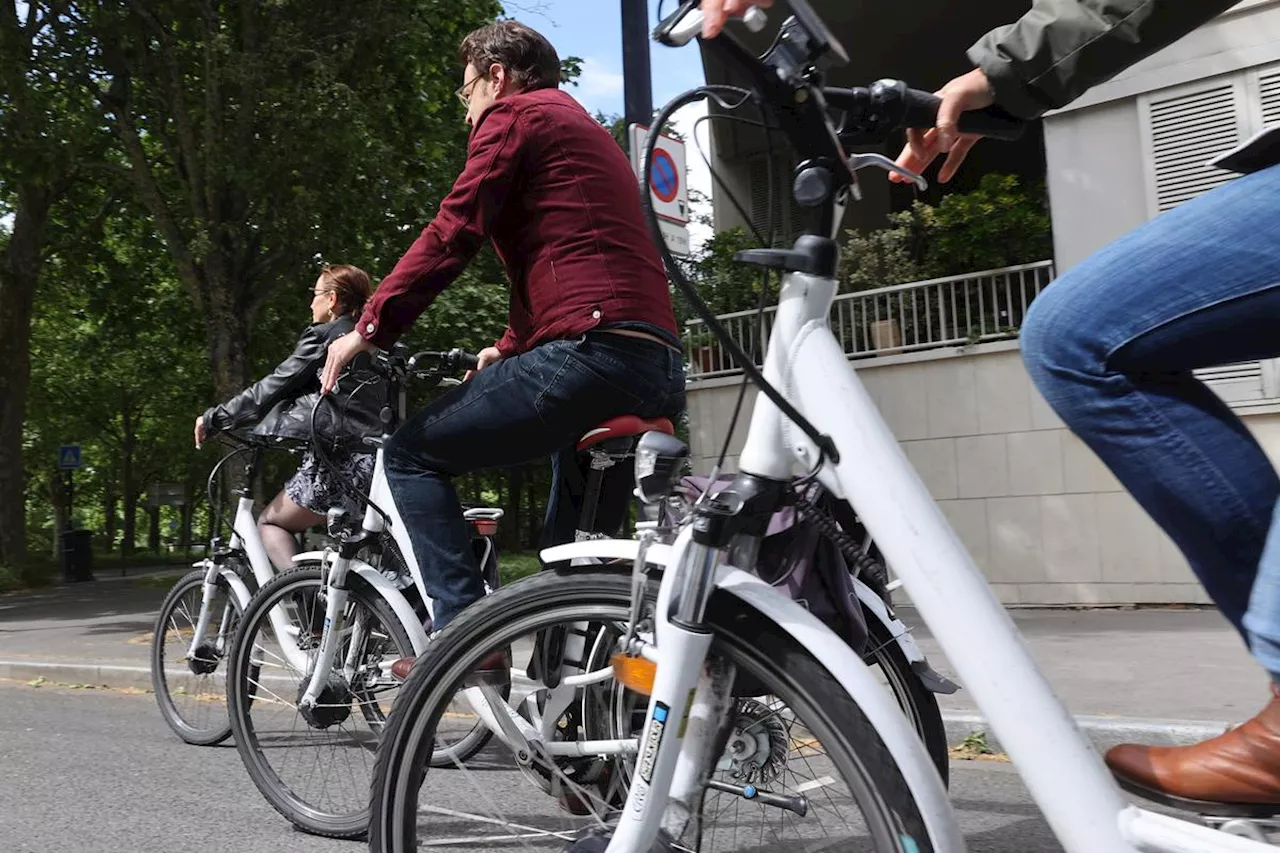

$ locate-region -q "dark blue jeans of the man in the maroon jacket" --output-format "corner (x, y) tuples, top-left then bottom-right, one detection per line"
(385, 332), (685, 629)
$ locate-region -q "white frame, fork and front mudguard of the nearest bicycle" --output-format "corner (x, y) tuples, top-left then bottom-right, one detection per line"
(543, 253), (1272, 853)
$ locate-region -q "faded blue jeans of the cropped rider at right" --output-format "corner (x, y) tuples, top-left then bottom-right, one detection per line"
(1021, 167), (1280, 676)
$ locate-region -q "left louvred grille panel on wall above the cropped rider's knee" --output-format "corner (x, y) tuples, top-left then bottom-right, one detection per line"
(1151, 83), (1242, 213)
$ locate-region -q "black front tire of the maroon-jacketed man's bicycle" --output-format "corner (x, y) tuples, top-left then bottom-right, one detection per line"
(227, 561), (413, 839)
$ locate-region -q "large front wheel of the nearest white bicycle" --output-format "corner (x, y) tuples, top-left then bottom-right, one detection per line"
(370, 570), (932, 853)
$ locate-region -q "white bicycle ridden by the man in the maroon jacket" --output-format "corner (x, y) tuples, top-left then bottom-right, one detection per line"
(212, 347), (503, 838)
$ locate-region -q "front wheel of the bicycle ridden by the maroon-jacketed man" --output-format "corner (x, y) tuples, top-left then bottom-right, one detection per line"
(227, 564), (413, 838)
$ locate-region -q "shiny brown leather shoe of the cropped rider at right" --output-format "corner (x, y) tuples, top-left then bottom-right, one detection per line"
(1107, 685), (1280, 817)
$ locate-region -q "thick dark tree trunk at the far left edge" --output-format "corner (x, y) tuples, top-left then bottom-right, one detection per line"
(0, 184), (54, 566)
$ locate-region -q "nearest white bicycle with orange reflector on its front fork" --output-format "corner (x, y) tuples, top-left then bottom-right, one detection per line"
(370, 0), (1271, 853)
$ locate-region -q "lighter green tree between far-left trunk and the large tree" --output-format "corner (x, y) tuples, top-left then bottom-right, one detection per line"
(27, 188), (211, 556)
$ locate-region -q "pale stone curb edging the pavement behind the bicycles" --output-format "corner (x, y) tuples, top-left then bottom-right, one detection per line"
(0, 660), (1230, 752)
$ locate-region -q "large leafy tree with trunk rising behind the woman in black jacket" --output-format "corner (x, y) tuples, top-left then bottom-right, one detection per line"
(63, 0), (500, 397)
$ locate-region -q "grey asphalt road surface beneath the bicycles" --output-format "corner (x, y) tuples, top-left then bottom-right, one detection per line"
(0, 681), (1111, 853)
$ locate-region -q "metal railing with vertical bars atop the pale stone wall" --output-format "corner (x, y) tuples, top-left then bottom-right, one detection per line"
(685, 260), (1053, 380)
